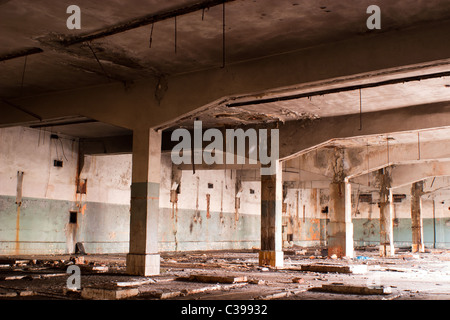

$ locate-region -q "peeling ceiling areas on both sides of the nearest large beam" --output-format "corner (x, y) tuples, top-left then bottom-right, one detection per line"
(0, 0), (450, 139)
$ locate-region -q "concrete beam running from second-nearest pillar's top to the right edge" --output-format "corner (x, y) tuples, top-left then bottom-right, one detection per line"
(279, 102), (450, 160)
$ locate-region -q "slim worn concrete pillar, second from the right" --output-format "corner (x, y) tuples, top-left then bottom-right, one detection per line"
(378, 169), (395, 257)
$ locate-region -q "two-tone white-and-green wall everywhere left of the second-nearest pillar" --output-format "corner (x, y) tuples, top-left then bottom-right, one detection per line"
(0, 127), (261, 254)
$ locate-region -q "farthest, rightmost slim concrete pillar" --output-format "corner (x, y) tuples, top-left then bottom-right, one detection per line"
(411, 181), (425, 252)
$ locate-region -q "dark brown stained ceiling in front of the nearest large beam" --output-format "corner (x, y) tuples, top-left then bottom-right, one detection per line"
(0, 0), (450, 98)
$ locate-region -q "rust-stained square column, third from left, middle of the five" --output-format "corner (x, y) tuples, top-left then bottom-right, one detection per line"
(327, 181), (354, 258)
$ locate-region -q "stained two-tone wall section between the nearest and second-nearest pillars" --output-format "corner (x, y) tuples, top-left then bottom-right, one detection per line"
(159, 154), (261, 251)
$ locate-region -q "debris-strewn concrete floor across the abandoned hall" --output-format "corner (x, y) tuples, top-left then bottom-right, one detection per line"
(0, 248), (450, 300)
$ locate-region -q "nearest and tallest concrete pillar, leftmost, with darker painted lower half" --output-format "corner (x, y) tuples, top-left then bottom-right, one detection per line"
(127, 129), (161, 276)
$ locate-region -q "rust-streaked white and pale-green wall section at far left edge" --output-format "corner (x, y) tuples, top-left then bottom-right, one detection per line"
(0, 127), (78, 254)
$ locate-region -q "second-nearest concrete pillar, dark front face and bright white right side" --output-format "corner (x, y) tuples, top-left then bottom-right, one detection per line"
(259, 161), (283, 267)
